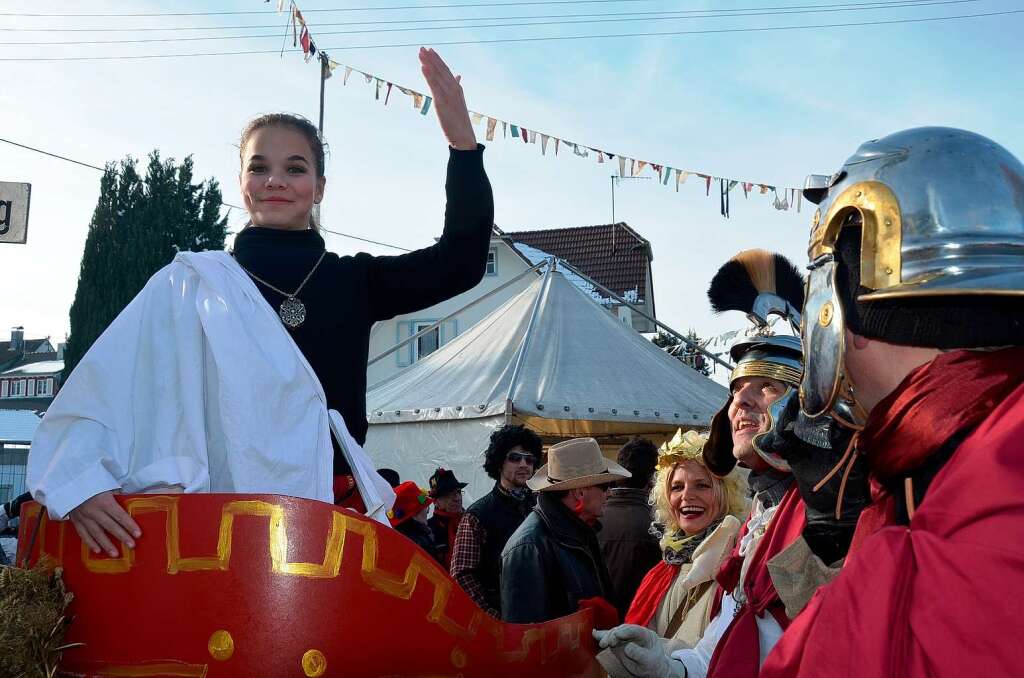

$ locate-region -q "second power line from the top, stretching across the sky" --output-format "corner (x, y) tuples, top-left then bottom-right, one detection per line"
(0, 0), (981, 31)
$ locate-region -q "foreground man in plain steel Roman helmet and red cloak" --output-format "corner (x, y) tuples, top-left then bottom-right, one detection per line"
(762, 127), (1024, 678)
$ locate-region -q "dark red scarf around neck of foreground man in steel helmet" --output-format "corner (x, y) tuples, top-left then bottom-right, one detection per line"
(850, 346), (1024, 553)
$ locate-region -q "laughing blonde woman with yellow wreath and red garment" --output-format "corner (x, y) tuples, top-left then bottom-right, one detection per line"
(626, 431), (746, 647)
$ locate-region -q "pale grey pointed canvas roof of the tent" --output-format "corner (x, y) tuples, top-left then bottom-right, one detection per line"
(367, 271), (728, 434)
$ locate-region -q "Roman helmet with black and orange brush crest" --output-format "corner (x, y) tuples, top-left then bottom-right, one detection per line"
(703, 250), (804, 476)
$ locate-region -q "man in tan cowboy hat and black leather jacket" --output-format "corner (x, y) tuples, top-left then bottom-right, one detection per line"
(502, 438), (631, 624)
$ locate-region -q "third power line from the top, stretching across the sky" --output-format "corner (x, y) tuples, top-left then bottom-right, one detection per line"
(3, 0), (981, 47)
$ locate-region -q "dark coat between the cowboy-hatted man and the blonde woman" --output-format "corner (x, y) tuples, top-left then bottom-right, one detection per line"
(597, 488), (662, 619)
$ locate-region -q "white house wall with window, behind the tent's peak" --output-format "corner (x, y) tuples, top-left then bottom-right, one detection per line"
(367, 240), (535, 388)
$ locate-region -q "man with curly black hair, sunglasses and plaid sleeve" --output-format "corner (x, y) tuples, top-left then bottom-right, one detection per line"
(451, 425), (543, 618)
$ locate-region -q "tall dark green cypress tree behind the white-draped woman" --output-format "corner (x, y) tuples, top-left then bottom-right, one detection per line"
(65, 151), (227, 378)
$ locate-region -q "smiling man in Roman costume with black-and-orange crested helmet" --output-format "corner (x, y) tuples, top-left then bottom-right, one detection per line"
(595, 250), (857, 678)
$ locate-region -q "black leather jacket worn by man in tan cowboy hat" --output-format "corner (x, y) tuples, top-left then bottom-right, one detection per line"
(502, 493), (610, 624)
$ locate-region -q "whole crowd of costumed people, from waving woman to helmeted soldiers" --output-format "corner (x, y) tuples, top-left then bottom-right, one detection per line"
(11, 43), (1024, 678)
